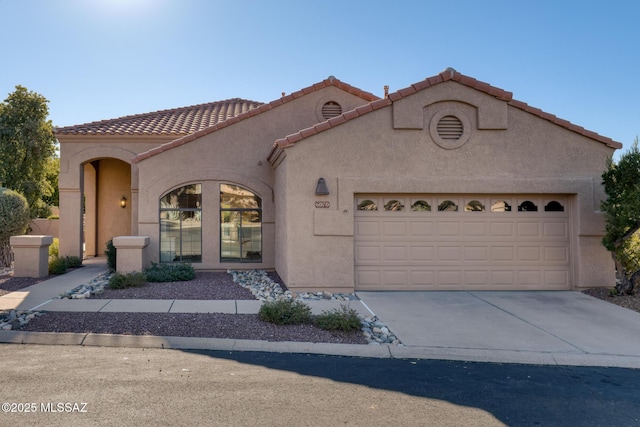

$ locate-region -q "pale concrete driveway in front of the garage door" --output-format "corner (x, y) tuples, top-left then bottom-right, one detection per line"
(357, 291), (640, 367)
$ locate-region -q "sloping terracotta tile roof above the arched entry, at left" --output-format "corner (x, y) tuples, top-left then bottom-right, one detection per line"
(55, 98), (263, 136)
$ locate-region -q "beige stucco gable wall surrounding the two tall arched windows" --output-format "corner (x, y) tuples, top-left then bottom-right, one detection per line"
(136, 87), (372, 269)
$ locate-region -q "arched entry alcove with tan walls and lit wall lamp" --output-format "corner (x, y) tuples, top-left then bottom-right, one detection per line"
(83, 158), (133, 257)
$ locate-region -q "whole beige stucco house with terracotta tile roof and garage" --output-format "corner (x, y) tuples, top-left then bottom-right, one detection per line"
(56, 68), (622, 292)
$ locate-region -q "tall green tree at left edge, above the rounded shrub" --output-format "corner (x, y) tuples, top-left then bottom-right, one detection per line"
(0, 86), (55, 217)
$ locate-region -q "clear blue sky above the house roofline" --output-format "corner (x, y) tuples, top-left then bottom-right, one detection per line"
(0, 0), (640, 154)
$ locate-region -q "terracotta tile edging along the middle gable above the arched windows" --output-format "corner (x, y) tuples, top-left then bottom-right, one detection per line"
(132, 76), (380, 163)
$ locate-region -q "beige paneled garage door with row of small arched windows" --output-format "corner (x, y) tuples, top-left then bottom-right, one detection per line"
(355, 194), (571, 290)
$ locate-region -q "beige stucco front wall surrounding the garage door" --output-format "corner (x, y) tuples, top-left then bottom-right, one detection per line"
(275, 82), (613, 291)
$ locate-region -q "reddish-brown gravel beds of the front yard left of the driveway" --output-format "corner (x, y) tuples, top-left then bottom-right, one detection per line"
(0, 272), (369, 344)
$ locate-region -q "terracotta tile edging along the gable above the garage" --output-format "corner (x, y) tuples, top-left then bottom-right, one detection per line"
(268, 68), (622, 160)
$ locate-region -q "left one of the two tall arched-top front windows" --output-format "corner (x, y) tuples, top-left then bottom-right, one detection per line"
(160, 184), (202, 262)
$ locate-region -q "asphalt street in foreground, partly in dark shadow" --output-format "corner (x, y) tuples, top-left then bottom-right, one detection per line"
(0, 344), (640, 427)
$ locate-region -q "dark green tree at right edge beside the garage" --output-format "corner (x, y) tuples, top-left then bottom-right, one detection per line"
(600, 137), (640, 295)
